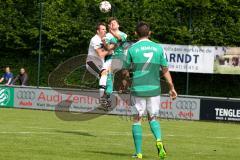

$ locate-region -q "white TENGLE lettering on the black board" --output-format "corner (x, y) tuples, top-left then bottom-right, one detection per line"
(215, 108), (240, 118)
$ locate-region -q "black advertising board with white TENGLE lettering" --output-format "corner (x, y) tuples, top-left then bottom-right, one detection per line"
(200, 99), (240, 121)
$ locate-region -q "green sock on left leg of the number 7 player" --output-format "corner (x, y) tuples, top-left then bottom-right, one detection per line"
(132, 123), (142, 154)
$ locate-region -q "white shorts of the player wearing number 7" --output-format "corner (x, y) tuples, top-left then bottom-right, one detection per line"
(131, 96), (161, 117)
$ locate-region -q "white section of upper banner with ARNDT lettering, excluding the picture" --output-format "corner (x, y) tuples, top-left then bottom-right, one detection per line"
(162, 44), (215, 73)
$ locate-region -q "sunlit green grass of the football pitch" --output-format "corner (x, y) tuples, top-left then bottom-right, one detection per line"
(0, 108), (240, 160)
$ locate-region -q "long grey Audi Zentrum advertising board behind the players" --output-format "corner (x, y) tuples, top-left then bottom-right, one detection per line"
(14, 88), (200, 120)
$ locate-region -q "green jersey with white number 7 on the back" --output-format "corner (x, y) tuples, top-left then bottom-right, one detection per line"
(127, 39), (168, 97)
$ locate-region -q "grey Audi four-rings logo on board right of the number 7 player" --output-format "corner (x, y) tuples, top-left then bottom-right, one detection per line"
(176, 100), (198, 110)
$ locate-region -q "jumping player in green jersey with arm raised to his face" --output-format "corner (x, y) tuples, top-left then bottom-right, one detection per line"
(103, 17), (127, 105)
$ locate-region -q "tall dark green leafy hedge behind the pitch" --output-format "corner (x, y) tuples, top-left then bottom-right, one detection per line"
(0, 0), (240, 96)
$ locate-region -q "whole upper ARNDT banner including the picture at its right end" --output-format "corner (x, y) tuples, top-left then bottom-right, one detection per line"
(162, 44), (240, 74)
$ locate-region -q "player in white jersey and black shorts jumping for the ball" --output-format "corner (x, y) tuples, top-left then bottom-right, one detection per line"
(86, 22), (112, 105)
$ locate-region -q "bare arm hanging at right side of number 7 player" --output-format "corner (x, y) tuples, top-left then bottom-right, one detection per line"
(162, 67), (177, 99)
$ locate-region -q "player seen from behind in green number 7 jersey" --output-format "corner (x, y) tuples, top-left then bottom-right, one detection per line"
(127, 22), (177, 160)
